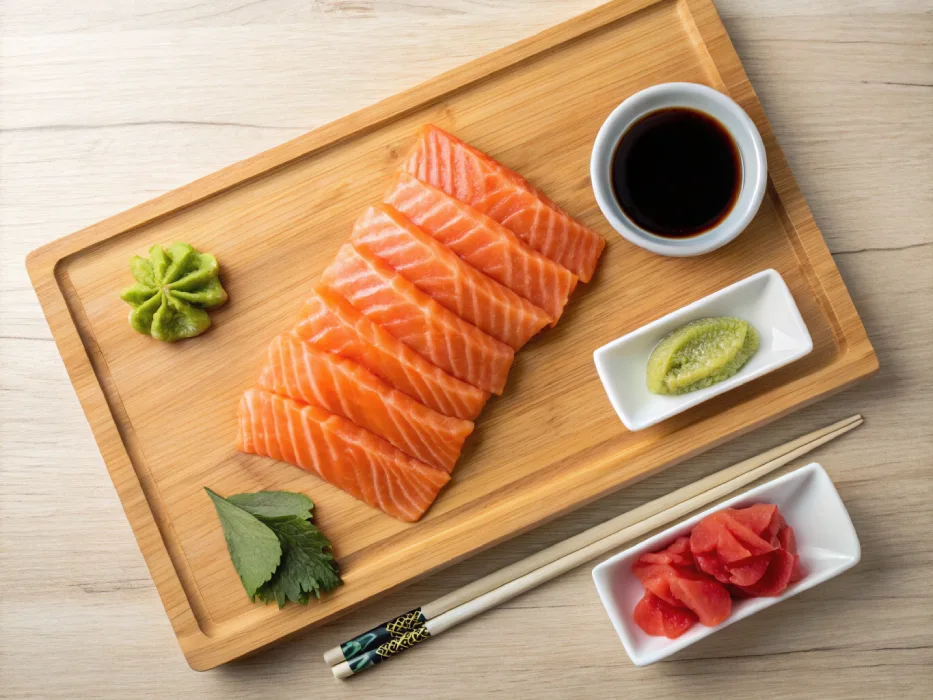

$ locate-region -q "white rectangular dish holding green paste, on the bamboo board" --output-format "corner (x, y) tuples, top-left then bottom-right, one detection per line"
(593, 270), (813, 431)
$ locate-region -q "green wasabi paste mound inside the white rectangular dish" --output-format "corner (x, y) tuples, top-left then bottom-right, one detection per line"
(647, 316), (759, 394)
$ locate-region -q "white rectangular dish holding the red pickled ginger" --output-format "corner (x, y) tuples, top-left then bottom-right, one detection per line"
(593, 462), (862, 666)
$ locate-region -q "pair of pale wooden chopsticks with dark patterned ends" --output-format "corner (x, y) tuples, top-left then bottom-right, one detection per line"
(324, 415), (863, 679)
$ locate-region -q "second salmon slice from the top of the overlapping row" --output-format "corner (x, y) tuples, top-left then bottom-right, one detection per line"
(384, 171), (577, 325)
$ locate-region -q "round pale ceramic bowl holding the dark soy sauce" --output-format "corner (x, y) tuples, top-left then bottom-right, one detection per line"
(590, 83), (768, 257)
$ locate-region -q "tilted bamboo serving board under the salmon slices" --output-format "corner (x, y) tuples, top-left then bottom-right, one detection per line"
(28, 0), (878, 669)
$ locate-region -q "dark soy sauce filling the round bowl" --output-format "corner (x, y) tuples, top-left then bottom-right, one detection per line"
(611, 107), (742, 238)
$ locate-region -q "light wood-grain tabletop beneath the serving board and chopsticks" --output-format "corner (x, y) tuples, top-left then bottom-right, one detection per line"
(0, 0), (933, 700)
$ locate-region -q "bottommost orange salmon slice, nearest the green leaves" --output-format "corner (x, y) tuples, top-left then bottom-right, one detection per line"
(236, 389), (450, 522)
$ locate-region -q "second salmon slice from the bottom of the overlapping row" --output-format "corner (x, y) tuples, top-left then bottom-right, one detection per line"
(258, 333), (473, 473)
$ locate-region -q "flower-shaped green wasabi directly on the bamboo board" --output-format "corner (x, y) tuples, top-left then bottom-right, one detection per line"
(120, 243), (227, 342)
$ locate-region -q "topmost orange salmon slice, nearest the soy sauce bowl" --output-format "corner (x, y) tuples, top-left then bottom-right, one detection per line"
(402, 124), (606, 282)
